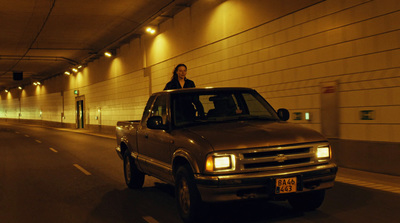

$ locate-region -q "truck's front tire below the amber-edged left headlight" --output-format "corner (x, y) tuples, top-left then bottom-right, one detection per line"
(175, 166), (206, 223)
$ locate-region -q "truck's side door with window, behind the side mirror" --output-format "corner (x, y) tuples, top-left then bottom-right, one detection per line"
(138, 95), (172, 180)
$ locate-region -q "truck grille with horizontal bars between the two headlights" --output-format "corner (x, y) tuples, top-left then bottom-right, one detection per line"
(237, 144), (321, 171)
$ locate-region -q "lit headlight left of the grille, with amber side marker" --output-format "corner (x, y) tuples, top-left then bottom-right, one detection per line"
(206, 155), (235, 172)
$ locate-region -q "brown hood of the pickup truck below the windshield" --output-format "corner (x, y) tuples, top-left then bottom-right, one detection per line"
(187, 121), (326, 151)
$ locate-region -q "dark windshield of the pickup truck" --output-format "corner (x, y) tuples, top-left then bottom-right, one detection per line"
(171, 91), (279, 127)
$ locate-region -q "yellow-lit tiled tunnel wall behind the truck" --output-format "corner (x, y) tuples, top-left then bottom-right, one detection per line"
(0, 0), (400, 142)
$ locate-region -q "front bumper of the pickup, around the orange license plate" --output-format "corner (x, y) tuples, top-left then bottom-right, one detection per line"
(195, 163), (337, 202)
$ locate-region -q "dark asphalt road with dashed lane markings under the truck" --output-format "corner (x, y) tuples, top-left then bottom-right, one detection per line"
(0, 123), (400, 223)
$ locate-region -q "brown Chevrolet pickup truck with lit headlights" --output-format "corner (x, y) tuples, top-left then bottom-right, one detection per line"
(116, 88), (337, 222)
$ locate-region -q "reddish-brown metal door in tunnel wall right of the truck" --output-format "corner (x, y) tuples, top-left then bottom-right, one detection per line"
(321, 81), (340, 138)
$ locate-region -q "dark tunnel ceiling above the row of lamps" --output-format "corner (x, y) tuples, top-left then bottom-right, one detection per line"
(0, 0), (195, 90)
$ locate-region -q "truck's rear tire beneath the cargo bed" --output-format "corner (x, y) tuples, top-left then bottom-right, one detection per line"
(124, 150), (145, 189)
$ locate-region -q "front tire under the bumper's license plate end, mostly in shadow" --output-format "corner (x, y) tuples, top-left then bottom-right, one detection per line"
(288, 190), (325, 211)
